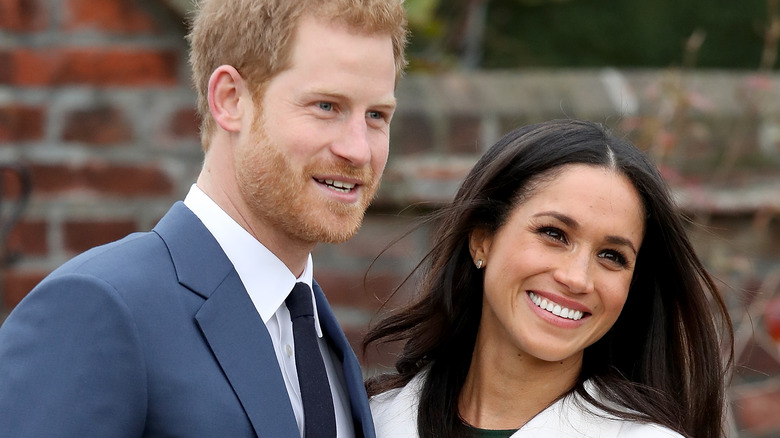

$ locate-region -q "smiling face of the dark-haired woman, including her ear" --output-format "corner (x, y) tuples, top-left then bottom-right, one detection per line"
(470, 164), (650, 361)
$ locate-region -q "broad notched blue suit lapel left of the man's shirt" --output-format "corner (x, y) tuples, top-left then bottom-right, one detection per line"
(154, 202), (299, 437)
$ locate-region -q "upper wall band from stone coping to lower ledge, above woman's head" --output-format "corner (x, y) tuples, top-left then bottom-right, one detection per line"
(384, 69), (780, 214)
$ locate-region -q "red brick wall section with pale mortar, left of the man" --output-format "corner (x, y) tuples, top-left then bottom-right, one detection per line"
(0, 0), (201, 312)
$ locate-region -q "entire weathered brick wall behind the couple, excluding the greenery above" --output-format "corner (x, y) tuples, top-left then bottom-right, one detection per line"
(0, 0), (780, 437)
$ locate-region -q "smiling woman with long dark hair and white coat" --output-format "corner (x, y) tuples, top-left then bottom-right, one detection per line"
(364, 120), (732, 438)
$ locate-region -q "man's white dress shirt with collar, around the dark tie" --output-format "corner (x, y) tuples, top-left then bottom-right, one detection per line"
(184, 184), (355, 437)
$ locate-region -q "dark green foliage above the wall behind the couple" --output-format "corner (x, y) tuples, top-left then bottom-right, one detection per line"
(407, 0), (771, 70)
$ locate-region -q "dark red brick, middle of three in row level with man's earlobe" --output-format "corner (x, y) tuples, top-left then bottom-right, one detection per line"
(62, 107), (133, 145)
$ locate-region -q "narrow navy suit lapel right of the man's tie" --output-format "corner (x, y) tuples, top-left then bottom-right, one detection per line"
(313, 282), (375, 438)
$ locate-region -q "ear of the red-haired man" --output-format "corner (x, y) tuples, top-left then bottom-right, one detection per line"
(208, 65), (246, 132)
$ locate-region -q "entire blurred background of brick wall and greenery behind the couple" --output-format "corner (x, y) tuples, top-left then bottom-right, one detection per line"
(0, 0), (780, 438)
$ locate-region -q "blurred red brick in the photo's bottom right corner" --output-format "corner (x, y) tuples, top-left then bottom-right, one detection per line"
(732, 389), (780, 436)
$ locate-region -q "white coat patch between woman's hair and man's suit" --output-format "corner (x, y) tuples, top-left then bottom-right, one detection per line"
(369, 373), (425, 438)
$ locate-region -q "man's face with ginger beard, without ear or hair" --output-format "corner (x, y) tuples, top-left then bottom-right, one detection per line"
(235, 18), (395, 243)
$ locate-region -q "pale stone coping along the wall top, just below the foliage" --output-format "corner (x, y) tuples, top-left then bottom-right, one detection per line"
(396, 68), (780, 120)
